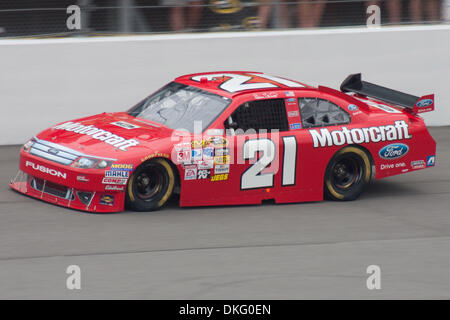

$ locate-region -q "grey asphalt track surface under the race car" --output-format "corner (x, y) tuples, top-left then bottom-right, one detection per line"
(0, 127), (450, 299)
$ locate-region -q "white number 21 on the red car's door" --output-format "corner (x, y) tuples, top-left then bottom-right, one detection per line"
(241, 136), (297, 190)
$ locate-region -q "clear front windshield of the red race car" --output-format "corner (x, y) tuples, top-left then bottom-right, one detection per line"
(128, 82), (231, 132)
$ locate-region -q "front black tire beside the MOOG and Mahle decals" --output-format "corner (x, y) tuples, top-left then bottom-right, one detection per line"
(127, 159), (175, 211)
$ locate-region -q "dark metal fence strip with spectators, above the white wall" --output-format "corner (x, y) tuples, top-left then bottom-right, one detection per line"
(0, 0), (450, 37)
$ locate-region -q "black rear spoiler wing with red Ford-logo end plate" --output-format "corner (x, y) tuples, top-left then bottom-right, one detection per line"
(341, 73), (434, 114)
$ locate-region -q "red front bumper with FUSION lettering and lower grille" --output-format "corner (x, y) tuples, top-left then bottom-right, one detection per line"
(10, 150), (126, 213)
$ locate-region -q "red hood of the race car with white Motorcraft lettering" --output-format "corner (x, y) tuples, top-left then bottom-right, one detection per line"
(37, 112), (173, 158)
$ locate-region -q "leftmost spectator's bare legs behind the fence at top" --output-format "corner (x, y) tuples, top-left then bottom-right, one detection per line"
(161, 0), (203, 31)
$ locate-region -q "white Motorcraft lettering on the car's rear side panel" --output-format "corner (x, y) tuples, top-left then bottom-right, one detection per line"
(309, 120), (412, 148)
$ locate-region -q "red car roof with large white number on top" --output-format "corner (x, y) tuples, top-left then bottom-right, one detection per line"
(175, 71), (312, 98)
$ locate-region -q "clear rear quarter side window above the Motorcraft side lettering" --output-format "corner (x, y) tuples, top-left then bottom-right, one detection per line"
(298, 98), (350, 128)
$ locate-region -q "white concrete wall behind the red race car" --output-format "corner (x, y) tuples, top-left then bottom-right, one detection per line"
(0, 25), (450, 145)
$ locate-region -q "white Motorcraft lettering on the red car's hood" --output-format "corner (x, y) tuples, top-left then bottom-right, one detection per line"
(53, 121), (139, 151)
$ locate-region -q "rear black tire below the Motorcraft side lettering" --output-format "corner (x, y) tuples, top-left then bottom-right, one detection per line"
(324, 146), (372, 201)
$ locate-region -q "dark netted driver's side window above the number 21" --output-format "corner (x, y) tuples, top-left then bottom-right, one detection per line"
(226, 99), (289, 132)
